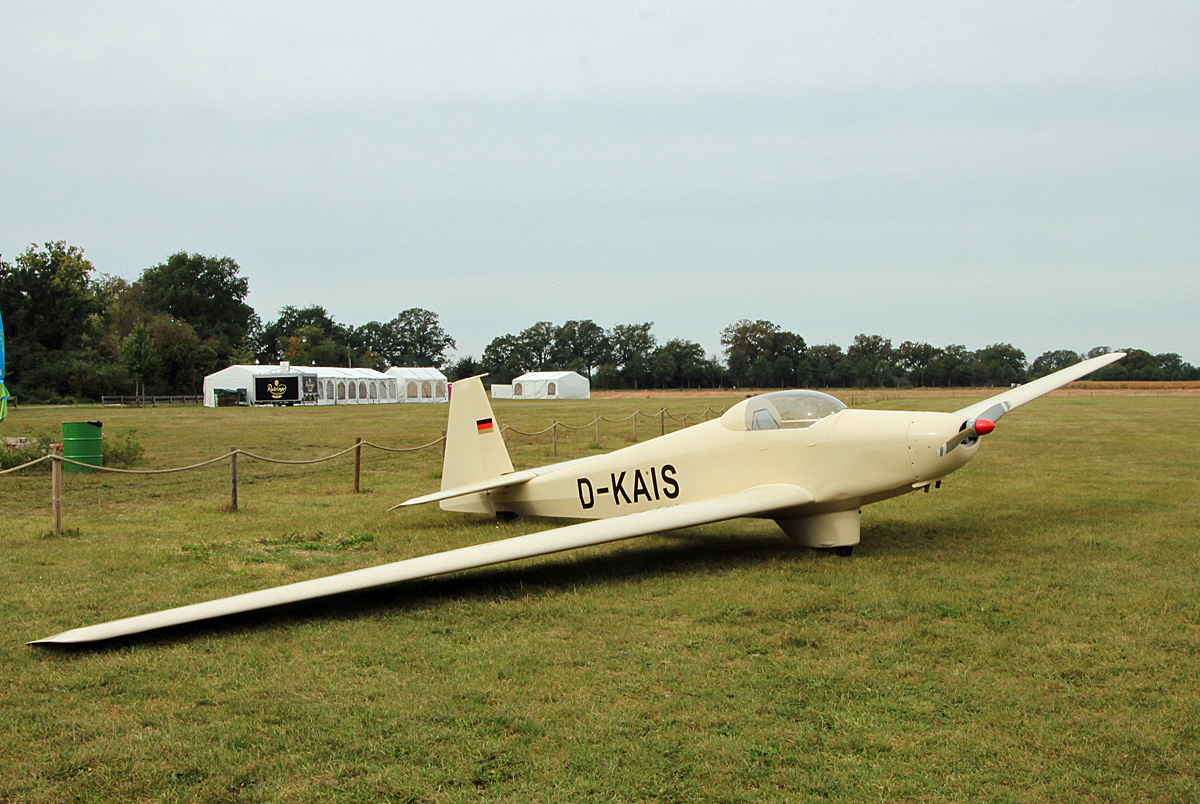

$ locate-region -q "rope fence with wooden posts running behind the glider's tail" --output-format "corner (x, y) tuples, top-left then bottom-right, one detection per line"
(0, 406), (726, 535)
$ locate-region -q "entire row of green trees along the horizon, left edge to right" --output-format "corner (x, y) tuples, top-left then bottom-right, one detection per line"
(0, 241), (1200, 403)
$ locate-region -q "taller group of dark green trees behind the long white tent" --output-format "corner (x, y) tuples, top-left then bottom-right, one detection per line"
(0, 241), (455, 403)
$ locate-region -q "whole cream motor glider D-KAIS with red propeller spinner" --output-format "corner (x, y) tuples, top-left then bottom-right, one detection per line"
(30, 352), (1124, 644)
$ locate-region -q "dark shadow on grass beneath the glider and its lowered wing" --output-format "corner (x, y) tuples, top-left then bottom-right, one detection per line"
(37, 521), (979, 655)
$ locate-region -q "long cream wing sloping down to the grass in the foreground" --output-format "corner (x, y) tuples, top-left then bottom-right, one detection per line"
(30, 485), (814, 644)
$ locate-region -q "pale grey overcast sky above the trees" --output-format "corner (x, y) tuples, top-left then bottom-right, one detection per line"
(0, 0), (1200, 364)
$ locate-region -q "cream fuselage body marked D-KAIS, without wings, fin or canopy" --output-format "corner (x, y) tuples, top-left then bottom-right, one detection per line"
(442, 403), (978, 520)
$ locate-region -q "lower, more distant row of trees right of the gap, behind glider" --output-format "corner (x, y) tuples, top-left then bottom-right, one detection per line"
(463, 319), (1200, 389)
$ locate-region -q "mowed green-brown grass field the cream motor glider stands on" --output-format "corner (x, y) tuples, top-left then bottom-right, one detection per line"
(0, 397), (1200, 804)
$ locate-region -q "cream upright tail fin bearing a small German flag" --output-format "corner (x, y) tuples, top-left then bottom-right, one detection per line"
(442, 374), (512, 491)
